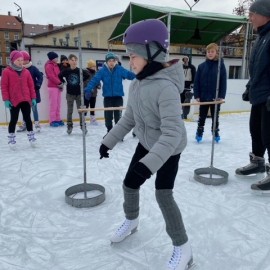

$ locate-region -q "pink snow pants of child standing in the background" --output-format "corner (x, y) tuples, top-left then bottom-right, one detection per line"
(48, 87), (62, 123)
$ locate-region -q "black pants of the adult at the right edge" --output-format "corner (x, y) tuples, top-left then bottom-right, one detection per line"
(249, 103), (270, 162)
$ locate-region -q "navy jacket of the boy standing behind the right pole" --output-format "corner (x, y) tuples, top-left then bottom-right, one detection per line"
(194, 59), (227, 102)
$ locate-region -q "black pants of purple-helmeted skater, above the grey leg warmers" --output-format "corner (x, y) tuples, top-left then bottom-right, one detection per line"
(124, 143), (180, 189)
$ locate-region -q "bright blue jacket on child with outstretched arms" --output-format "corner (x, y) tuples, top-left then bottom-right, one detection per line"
(84, 63), (135, 97)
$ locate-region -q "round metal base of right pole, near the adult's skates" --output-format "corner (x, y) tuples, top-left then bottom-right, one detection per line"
(194, 167), (229, 186)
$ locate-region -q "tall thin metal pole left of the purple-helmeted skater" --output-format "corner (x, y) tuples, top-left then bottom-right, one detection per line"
(78, 30), (87, 198)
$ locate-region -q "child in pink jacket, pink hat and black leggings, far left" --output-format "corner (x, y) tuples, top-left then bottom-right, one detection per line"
(1, 51), (36, 147)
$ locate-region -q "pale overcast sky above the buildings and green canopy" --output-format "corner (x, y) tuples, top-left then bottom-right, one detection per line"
(0, 0), (238, 26)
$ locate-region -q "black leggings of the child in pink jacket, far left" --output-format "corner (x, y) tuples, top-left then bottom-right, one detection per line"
(8, 101), (33, 133)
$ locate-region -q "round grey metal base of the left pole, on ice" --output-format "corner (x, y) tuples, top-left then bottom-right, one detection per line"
(65, 184), (105, 208)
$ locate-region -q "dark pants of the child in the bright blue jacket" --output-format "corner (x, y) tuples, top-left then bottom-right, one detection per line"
(103, 97), (123, 132)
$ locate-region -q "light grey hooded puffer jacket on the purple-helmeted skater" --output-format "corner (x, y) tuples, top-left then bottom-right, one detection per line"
(102, 63), (187, 174)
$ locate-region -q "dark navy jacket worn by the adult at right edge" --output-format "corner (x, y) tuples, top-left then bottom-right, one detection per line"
(247, 22), (270, 105)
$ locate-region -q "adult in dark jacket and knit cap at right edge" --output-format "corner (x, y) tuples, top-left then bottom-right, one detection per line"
(236, 0), (270, 193)
